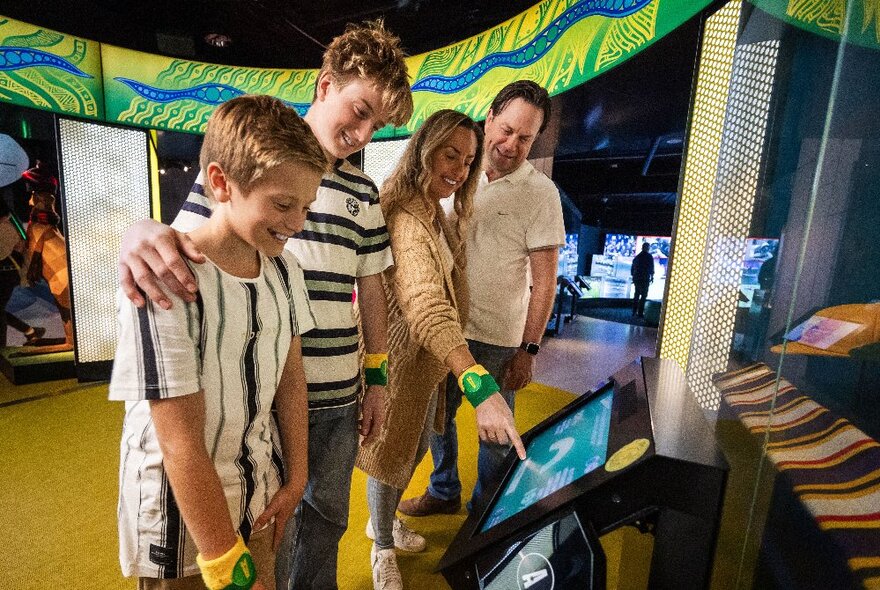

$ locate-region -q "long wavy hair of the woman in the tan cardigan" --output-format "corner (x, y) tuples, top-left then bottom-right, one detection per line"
(379, 109), (483, 257)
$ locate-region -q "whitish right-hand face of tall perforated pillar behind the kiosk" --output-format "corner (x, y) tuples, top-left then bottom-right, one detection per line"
(686, 40), (779, 410)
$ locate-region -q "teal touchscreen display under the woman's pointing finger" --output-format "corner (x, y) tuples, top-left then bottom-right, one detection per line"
(480, 388), (614, 532)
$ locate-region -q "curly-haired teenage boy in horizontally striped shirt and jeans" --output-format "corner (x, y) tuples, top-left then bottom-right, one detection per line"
(120, 23), (412, 590)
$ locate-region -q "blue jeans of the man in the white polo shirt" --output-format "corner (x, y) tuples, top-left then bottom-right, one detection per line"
(428, 340), (517, 510)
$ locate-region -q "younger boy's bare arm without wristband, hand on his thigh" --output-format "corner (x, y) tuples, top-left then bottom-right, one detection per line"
(254, 336), (309, 551)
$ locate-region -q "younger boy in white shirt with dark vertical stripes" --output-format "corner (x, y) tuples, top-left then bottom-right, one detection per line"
(110, 96), (328, 590)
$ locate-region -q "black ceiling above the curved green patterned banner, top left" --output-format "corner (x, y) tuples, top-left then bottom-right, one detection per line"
(0, 0), (537, 68)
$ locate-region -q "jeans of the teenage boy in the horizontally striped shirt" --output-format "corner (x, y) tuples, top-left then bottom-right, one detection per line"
(275, 404), (358, 590)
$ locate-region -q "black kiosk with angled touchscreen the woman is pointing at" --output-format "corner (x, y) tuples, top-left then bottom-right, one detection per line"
(438, 358), (727, 590)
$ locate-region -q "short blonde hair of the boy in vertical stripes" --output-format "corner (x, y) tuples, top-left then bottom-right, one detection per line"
(199, 95), (329, 196)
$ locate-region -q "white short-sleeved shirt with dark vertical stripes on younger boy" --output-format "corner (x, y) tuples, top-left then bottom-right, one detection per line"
(110, 252), (314, 578)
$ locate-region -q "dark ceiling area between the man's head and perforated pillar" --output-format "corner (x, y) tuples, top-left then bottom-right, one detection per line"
(553, 19), (700, 235)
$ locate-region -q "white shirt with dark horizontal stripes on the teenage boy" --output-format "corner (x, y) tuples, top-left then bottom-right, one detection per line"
(172, 160), (392, 410)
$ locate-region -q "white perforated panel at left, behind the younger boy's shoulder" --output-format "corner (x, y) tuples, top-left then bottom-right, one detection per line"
(59, 119), (150, 363)
